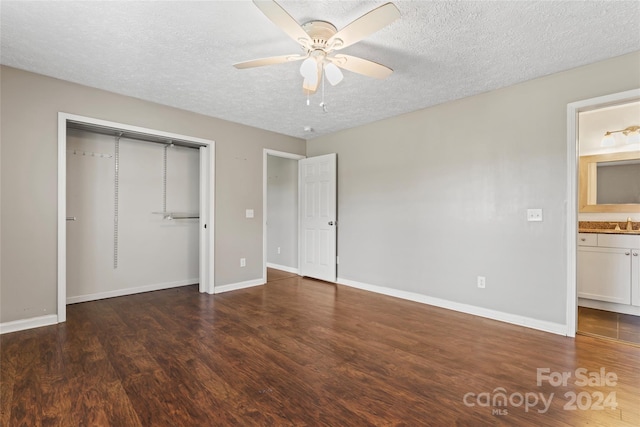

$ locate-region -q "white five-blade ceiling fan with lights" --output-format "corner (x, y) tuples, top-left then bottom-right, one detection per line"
(233, 0), (400, 95)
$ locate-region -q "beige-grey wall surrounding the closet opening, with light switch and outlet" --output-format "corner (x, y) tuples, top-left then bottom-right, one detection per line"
(0, 66), (306, 326)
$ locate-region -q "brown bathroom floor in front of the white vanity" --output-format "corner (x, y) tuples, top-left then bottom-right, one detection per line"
(578, 307), (640, 345)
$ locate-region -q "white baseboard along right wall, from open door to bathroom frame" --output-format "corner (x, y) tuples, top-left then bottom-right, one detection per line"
(338, 277), (567, 335)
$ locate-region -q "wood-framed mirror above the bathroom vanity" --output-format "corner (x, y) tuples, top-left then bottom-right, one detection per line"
(578, 151), (640, 212)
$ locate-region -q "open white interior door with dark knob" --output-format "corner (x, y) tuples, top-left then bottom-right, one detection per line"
(298, 153), (337, 282)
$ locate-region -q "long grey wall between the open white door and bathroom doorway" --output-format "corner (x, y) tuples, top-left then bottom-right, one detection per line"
(307, 52), (640, 330)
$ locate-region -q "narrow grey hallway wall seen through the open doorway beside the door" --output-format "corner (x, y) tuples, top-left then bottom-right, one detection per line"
(267, 155), (298, 269)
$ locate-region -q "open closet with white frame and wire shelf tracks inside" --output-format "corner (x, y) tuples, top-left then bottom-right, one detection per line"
(57, 113), (215, 322)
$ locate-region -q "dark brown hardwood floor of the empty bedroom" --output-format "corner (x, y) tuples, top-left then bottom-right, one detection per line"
(0, 276), (640, 427)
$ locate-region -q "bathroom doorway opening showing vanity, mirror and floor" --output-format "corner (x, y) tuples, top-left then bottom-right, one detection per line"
(570, 90), (640, 345)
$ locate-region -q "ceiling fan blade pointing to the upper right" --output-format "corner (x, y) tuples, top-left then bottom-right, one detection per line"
(327, 3), (400, 50)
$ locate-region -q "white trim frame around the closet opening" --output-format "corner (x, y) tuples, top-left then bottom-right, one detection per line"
(57, 112), (215, 323)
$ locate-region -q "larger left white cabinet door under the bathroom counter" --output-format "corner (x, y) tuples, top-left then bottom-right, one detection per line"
(578, 247), (631, 304)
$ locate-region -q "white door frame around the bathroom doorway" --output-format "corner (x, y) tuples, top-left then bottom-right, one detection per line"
(566, 89), (640, 337)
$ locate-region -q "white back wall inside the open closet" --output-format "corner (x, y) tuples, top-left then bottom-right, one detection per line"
(67, 129), (200, 302)
